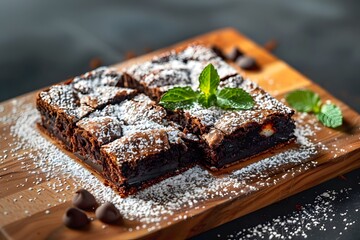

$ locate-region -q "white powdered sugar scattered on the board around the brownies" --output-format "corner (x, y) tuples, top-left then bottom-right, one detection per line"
(6, 103), (318, 223)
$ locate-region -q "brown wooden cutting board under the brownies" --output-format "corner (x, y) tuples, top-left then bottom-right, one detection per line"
(0, 28), (360, 239)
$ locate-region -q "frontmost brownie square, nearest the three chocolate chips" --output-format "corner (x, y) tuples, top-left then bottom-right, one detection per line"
(101, 129), (187, 196)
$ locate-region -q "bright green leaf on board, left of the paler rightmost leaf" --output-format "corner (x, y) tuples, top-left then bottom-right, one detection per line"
(285, 90), (321, 113)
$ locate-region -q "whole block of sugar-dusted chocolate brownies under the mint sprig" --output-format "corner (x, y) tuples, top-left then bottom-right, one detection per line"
(37, 45), (295, 196)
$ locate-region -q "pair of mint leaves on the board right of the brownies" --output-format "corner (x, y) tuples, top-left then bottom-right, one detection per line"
(285, 90), (343, 128)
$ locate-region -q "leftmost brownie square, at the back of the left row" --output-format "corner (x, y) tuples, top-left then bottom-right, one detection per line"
(36, 67), (136, 150)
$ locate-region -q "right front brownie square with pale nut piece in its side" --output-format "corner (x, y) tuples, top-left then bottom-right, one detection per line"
(175, 75), (295, 170)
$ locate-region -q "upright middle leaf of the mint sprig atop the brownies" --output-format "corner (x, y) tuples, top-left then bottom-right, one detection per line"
(199, 63), (220, 97)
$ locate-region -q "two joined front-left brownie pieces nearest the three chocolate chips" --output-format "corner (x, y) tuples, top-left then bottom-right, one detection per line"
(73, 94), (199, 196)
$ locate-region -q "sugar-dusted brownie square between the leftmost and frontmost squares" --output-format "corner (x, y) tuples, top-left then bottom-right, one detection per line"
(72, 94), (166, 165)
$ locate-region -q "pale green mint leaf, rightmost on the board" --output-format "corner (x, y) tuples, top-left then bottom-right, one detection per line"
(316, 103), (343, 128)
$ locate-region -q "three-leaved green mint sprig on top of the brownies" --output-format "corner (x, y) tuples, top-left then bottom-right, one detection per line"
(159, 64), (255, 110)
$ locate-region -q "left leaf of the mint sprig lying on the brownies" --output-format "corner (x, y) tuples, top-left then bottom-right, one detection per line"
(159, 87), (199, 110)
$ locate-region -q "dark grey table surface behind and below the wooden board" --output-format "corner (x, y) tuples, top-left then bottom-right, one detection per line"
(0, 0), (360, 239)
